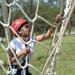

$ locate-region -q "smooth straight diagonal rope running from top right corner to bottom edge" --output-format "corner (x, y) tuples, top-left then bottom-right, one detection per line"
(41, 1), (75, 75)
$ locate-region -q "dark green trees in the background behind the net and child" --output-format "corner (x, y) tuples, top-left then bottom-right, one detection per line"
(0, 0), (75, 36)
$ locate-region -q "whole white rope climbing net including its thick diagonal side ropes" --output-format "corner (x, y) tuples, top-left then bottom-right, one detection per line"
(0, 0), (75, 75)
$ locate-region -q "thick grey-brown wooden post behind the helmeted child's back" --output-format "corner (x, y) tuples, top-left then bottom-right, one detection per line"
(2, 0), (12, 42)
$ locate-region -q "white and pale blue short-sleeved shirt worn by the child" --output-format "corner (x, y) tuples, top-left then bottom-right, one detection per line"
(10, 36), (36, 65)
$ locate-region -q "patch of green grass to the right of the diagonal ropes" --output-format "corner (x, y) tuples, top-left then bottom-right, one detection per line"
(57, 35), (75, 75)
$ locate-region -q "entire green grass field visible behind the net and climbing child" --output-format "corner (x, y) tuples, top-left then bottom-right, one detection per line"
(0, 35), (75, 75)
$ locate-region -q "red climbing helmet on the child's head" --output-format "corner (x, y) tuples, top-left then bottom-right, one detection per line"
(11, 18), (28, 31)
